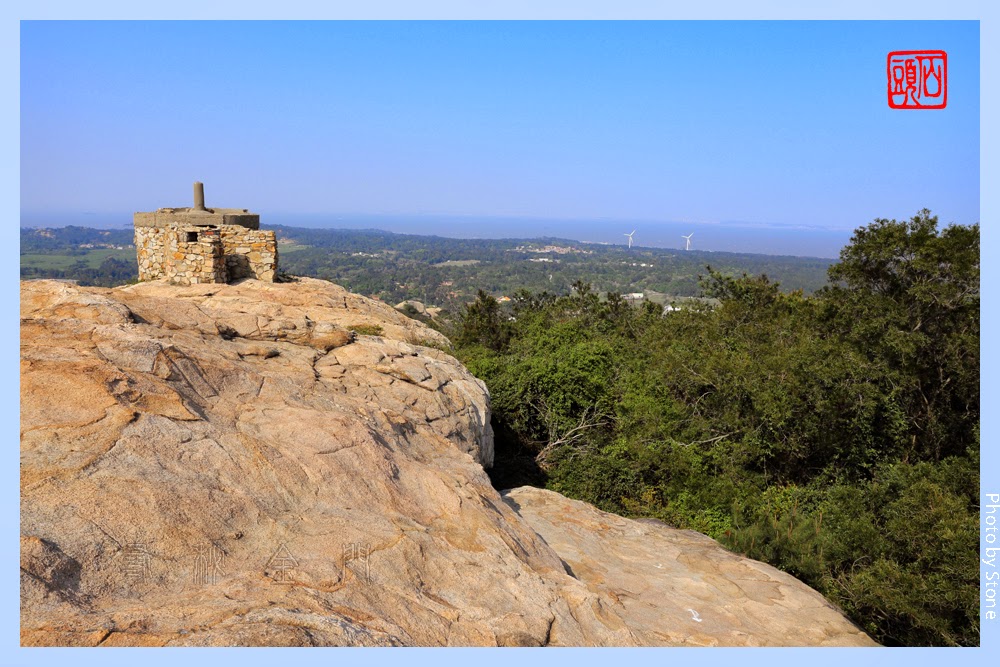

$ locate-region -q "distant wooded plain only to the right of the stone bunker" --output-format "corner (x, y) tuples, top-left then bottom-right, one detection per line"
(270, 226), (831, 306)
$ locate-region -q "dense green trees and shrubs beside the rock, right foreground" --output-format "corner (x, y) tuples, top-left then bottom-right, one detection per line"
(450, 210), (979, 646)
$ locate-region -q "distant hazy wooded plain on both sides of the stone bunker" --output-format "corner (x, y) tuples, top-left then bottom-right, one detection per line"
(21, 225), (831, 302)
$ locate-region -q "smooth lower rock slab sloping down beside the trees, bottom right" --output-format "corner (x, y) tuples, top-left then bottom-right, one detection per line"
(503, 486), (874, 646)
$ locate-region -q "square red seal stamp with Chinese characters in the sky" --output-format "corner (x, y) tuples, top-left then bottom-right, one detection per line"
(885, 51), (948, 109)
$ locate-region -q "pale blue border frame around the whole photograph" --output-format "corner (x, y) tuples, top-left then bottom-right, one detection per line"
(0, 0), (1000, 667)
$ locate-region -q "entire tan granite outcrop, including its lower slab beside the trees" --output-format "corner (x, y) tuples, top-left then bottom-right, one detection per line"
(21, 279), (870, 646)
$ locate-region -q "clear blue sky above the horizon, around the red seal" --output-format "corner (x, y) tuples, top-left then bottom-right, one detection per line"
(21, 22), (979, 253)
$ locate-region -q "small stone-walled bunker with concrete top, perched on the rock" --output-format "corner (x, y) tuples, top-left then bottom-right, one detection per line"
(132, 182), (278, 285)
